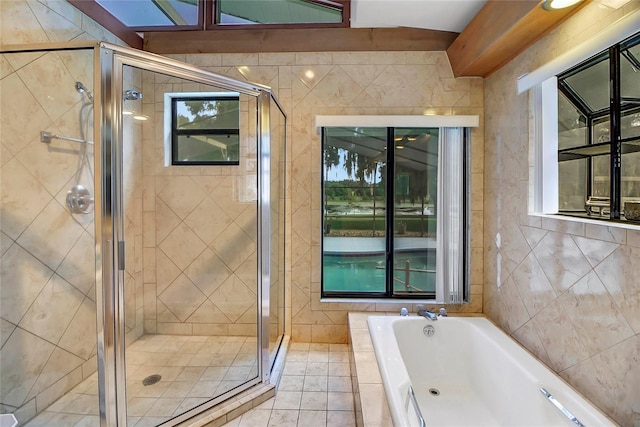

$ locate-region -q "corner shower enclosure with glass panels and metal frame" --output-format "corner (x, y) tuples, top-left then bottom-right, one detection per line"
(0, 42), (286, 426)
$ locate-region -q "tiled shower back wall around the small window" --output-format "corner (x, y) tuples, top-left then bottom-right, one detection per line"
(142, 72), (258, 336)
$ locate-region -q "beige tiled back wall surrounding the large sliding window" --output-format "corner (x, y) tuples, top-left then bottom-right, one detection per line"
(166, 52), (484, 343)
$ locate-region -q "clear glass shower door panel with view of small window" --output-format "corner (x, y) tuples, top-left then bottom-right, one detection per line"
(112, 54), (268, 425)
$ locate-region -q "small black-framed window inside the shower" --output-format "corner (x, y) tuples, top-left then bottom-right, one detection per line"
(167, 93), (240, 165)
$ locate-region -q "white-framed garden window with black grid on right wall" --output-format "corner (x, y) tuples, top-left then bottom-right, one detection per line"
(518, 11), (640, 223)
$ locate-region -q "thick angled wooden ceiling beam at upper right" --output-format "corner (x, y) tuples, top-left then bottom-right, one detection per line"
(447, 0), (589, 77)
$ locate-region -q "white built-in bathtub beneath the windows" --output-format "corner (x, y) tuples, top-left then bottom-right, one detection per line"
(368, 316), (615, 427)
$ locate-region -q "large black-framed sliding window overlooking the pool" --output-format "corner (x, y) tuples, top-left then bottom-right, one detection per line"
(322, 127), (468, 303)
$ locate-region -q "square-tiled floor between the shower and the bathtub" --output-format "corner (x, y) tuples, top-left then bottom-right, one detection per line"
(224, 343), (355, 427)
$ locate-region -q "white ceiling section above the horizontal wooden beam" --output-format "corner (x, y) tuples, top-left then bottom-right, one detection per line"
(351, 0), (487, 33)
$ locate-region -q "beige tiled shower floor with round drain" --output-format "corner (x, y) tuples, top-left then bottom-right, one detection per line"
(25, 335), (257, 427)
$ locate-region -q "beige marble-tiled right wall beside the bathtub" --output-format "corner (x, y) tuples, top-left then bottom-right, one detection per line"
(484, 2), (640, 426)
